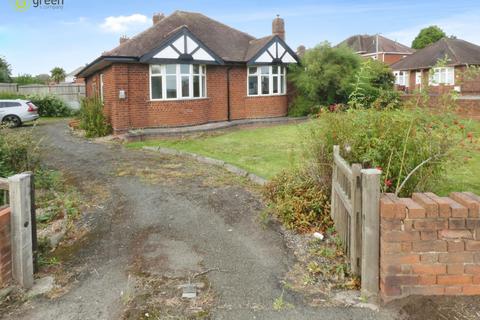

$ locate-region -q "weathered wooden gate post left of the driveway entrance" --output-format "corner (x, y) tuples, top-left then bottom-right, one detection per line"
(8, 173), (33, 289)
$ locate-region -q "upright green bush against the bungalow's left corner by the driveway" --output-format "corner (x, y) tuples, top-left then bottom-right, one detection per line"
(79, 97), (112, 138)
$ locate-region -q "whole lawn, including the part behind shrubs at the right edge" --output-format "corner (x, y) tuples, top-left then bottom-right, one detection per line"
(128, 120), (480, 195)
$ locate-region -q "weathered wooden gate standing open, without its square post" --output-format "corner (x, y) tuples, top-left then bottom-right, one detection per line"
(332, 146), (362, 274)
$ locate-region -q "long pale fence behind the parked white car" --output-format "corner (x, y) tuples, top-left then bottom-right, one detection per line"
(0, 83), (85, 109)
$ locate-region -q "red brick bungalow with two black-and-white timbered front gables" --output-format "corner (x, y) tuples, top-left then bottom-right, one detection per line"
(77, 11), (298, 133)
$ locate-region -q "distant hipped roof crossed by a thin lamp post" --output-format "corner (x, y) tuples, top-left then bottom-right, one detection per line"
(337, 35), (415, 54)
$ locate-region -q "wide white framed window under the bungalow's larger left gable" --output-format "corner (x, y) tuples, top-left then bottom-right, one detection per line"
(150, 64), (207, 101)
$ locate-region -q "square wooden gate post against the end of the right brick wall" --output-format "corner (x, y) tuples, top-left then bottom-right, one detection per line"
(362, 169), (382, 296)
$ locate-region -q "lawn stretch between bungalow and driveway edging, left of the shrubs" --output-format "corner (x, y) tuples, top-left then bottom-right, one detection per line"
(128, 123), (309, 179)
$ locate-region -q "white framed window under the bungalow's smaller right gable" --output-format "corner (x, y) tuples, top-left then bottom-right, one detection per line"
(247, 65), (287, 96)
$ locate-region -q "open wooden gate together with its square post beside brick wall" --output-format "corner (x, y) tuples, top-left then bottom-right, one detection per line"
(331, 146), (381, 294)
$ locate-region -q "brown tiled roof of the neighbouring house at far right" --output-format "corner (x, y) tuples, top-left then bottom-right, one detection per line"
(391, 38), (480, 70)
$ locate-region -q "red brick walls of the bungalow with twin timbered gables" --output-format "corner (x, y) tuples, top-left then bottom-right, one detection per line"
(86, 64), (288, 133)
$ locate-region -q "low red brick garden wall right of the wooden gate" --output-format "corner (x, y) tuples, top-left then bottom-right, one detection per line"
(380, 192), (480, 301)
